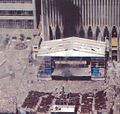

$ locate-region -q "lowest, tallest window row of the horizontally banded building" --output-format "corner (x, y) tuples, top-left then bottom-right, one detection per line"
(0, 20), (34, 29)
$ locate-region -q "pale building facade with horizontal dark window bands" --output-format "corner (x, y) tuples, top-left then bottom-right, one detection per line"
(0, 0), (36, 29)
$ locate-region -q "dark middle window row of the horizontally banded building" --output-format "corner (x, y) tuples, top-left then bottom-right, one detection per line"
(0, 10), (33, 16)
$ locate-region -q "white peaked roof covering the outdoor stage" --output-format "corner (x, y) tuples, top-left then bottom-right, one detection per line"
(38, 37), (105, 57)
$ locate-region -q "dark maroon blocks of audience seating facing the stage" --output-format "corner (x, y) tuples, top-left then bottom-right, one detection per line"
(19, 90), (107, 113)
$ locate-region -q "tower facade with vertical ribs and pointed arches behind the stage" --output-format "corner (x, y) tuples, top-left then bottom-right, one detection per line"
(41, 0), (120, 40)
